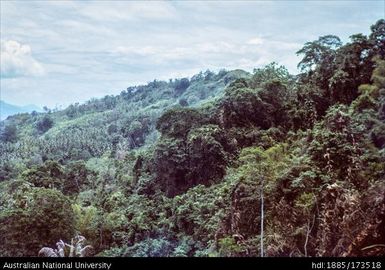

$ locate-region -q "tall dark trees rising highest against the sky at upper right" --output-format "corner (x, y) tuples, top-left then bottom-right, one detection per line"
(297, 20), (385, 104)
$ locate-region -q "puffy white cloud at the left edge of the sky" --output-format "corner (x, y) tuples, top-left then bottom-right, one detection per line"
(0, 40), (44, 78)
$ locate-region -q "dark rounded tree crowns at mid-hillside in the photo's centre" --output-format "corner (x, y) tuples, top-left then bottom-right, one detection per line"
(154, 125), (232, 196)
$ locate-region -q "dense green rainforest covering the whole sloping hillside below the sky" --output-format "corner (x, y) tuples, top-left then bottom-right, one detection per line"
(0, 20), (385, 257)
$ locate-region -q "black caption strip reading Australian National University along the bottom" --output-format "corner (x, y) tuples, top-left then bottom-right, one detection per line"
(0, 254), (385, 270)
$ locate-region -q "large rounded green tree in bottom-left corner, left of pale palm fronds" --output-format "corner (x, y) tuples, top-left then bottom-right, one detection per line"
(0, 186), (74, 256)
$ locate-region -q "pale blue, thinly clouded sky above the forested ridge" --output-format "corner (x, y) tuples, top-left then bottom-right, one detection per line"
(0, 0), (385, 108)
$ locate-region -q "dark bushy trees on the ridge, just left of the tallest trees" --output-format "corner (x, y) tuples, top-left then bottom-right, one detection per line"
(219, 63), (294, 129)
